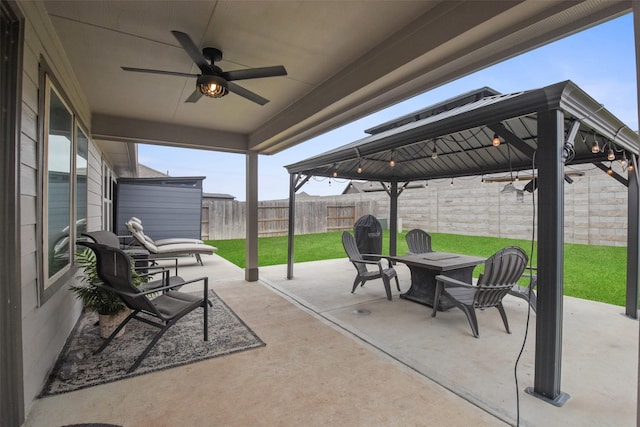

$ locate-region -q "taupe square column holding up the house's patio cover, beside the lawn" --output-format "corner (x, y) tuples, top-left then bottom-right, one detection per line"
(244, 151), (258, 282)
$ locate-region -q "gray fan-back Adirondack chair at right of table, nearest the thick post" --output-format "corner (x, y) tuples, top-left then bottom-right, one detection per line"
(431, 246), (528, 338)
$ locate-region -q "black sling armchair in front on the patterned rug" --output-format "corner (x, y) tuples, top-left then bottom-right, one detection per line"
(82, 242), (209, 373)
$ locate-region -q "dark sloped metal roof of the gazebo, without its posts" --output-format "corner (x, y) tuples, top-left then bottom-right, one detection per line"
(285, 81), (640, 182)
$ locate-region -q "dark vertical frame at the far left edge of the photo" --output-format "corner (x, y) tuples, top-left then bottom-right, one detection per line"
(0, 1), (25, 427)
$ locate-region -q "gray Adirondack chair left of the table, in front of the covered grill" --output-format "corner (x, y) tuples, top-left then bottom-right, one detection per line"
(342, 231), (400, 301)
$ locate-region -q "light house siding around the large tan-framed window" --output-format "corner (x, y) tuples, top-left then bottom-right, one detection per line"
(17, 2), (101, 412)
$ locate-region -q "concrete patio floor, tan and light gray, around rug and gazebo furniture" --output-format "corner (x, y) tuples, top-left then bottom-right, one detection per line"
(25, 255), (638, 427)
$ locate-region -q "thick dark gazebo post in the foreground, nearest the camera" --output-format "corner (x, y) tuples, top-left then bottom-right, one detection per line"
(526, 109), (569, 406)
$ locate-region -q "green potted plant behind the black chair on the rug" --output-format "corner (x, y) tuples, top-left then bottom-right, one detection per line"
(69, 249), (146, 338)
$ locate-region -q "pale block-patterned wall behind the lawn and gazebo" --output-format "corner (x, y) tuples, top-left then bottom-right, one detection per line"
(204, 165), (627, 246)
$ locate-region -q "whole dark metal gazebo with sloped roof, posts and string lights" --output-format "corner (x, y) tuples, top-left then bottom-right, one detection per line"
(286, 81), (640, 406)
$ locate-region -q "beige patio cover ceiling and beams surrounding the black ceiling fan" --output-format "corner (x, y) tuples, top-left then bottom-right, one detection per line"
(44, 0), (631, 174)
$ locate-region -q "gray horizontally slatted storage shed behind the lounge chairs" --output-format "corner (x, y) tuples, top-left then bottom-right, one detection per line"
(115, 177), (206, 240)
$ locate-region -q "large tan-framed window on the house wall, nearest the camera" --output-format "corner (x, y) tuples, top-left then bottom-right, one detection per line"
(38, 65), (89, 304)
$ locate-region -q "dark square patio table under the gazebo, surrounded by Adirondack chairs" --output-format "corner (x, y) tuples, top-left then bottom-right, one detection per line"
(390, 252), (486, 311)
